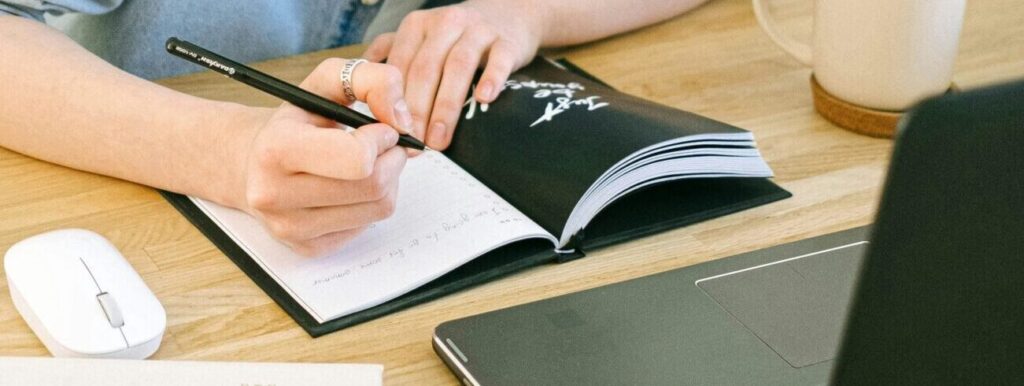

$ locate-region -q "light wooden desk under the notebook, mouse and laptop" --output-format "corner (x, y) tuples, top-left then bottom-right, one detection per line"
(0, 0), (1024, 385)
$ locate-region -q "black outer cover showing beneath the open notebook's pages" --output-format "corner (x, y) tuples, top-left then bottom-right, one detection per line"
(161, 60), (792, 337)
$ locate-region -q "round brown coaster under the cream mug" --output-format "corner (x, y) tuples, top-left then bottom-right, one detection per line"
(811, 74), (903, 138)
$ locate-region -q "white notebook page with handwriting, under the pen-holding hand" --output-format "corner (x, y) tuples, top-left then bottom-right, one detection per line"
(191, 152), (555, 323)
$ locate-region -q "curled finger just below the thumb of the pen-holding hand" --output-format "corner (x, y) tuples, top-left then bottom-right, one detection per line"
(247, 147), (407, 212)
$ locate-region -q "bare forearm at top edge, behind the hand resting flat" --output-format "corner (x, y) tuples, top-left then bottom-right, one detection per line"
(467, 0), (707, 47)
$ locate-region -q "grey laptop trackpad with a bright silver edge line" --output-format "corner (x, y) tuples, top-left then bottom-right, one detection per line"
(697, 242), (867, 368)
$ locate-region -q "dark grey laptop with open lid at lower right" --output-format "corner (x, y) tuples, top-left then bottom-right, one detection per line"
(433, 78), (1024, 385)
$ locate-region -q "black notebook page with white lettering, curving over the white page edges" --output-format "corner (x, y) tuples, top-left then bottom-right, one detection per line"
(444, 58), (760, 241)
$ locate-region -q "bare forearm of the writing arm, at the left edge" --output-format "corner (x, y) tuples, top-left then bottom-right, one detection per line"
(0, 16), (256, 205)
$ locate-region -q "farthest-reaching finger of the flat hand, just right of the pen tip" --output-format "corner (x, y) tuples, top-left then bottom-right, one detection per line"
(427, 29), (498, 151)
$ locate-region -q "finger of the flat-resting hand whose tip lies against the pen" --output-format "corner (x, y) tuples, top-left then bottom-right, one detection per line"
(406, 23), (462, 145)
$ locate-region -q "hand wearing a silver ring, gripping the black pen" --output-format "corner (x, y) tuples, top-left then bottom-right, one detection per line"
(238, 58), (412, 256)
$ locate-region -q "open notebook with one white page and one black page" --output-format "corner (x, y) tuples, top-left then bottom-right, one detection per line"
(159, 60), (787, 335)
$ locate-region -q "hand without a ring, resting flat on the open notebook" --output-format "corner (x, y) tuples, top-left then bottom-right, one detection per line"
(364, 1), (540, 149)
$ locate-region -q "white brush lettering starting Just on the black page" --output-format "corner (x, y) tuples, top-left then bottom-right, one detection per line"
(463, 80), (608, 127)
